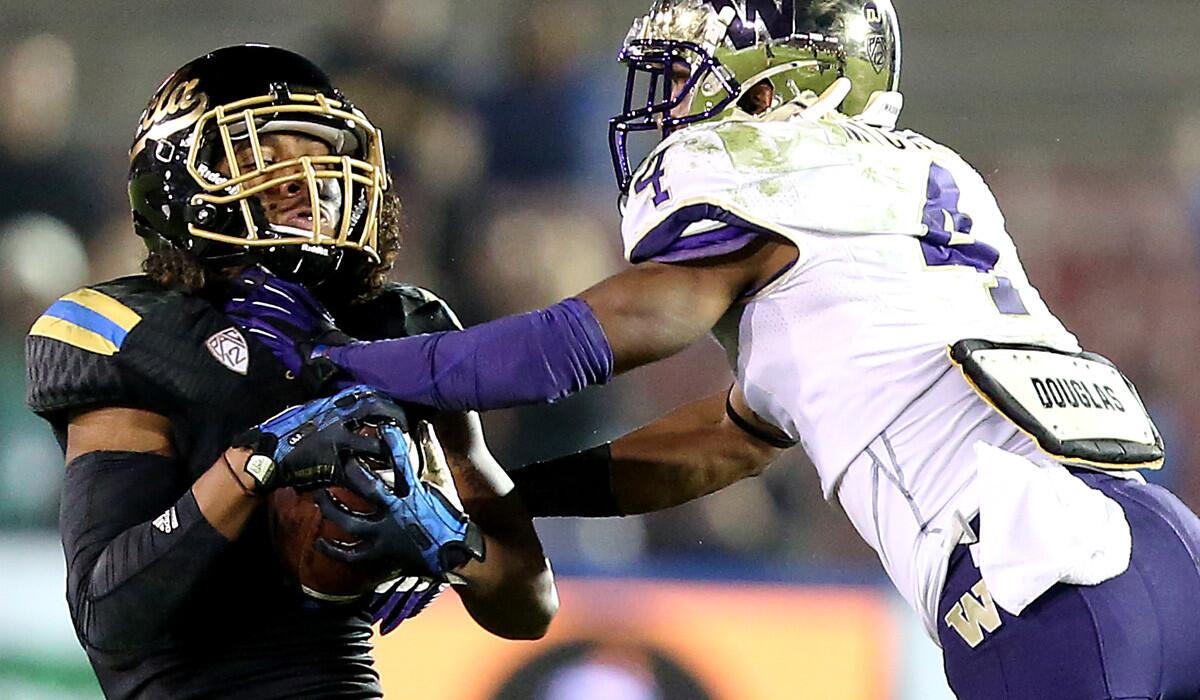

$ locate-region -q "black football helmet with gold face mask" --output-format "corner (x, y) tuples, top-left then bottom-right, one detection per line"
(130, 44), (389, 282)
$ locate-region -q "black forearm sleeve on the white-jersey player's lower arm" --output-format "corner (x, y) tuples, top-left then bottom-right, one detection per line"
(509, 443), (625, 517)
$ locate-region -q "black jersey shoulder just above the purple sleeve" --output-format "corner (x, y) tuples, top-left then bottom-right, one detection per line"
(334, 282), (462, 340)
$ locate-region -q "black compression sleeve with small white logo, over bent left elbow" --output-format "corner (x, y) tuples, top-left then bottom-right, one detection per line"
(59, 451), (229, 652)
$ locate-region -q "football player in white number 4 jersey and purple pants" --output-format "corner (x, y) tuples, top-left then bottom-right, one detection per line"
(231, 0), (1200, 700)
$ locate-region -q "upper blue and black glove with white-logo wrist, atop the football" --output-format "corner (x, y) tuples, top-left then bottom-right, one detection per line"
(232, 384), (407, 492)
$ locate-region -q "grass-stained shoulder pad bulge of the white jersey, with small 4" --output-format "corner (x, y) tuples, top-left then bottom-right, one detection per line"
(622, 119), (931, 263)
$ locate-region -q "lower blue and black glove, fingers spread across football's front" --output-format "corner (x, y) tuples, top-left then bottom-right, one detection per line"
(316, 424), (484, 584)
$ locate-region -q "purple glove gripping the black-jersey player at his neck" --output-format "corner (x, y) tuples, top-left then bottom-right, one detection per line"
(222, 267), (353, 394)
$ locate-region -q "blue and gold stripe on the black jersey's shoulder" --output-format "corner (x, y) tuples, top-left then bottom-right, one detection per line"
(29, 288), (142, 355)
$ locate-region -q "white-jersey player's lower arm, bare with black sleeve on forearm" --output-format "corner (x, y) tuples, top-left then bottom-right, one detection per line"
(511, 387), (790, 517)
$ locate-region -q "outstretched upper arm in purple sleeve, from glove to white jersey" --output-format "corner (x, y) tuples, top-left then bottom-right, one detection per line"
(318, 238), (796, 411)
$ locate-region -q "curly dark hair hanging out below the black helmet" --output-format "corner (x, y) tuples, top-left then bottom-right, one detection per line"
(142, 192), (402, 304)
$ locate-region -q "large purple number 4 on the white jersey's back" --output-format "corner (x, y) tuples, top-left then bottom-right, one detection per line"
(920, 163), (1028, 315)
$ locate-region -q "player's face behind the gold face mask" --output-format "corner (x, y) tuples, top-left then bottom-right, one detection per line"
(221, 133), (340, 231)
